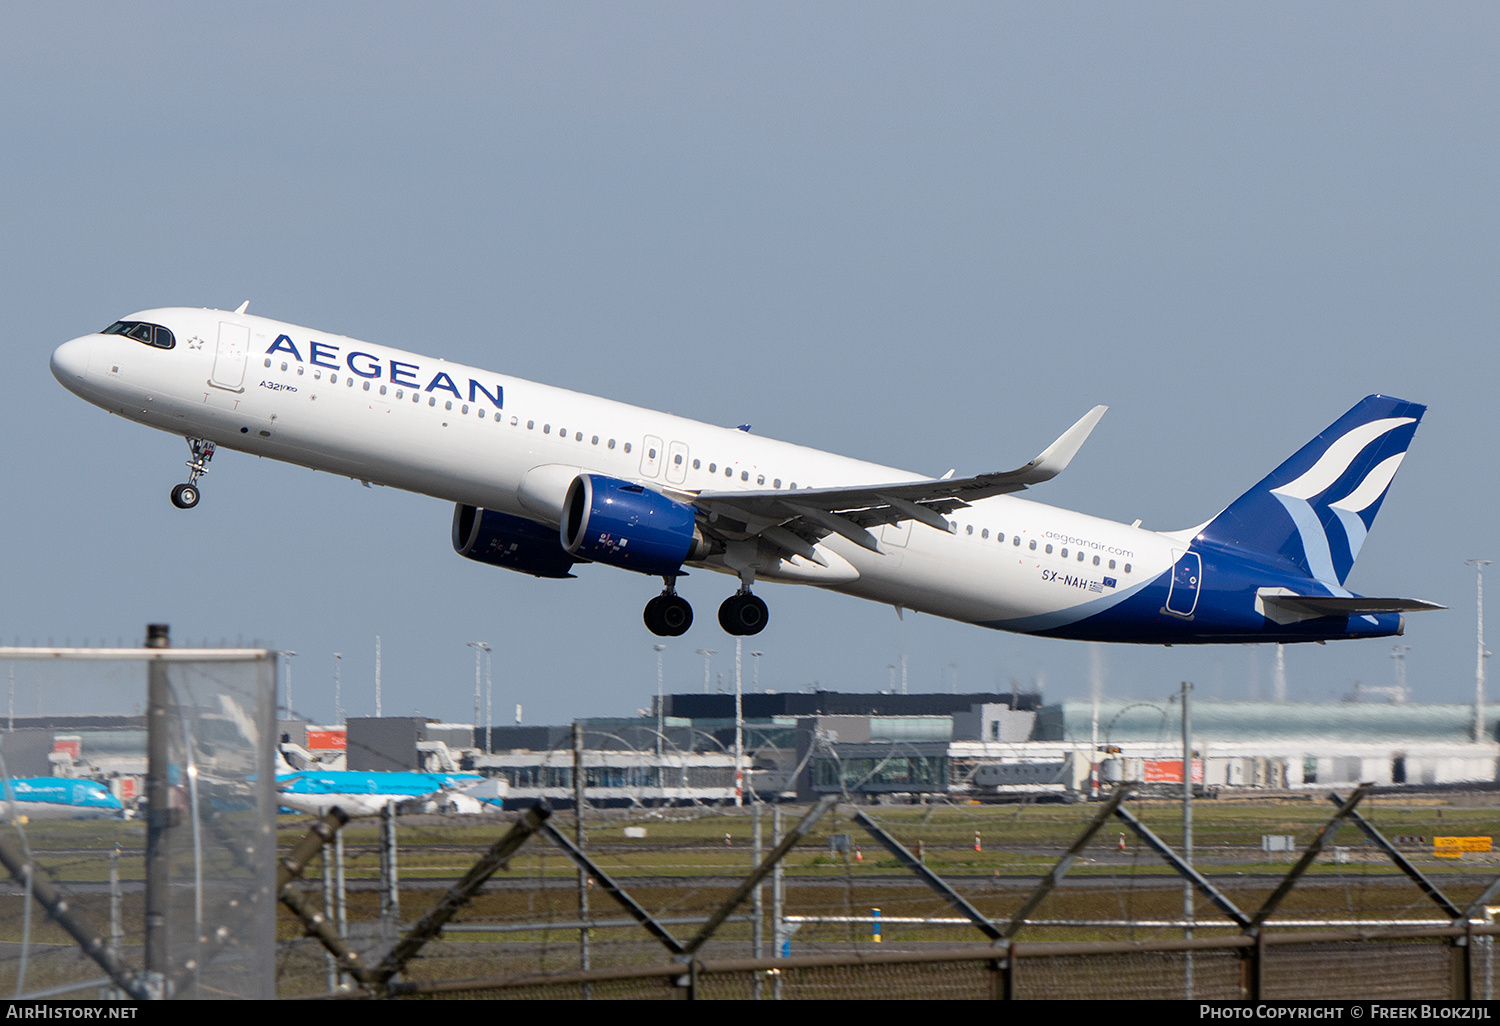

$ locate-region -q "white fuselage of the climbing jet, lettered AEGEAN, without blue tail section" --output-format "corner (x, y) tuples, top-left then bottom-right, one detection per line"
(53, 309), (1184, 630)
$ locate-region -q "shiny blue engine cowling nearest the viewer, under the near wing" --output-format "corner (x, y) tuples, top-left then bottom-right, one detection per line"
(561, 474), (708, 576)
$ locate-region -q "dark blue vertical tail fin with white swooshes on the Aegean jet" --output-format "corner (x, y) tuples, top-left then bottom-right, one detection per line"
(1197, 396), (1427, 588)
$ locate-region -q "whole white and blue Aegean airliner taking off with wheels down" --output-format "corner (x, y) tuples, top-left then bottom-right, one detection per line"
(53, 306), (1442, 645)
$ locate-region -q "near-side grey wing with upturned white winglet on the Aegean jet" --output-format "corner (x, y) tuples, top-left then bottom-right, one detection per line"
(693, 407), (1109, 563)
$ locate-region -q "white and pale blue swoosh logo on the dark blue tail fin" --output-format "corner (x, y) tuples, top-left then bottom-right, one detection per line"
(1271, 417), (1416, 585)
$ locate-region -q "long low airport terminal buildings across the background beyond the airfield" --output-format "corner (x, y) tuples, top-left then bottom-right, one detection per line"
(3, 692), (1500, 806)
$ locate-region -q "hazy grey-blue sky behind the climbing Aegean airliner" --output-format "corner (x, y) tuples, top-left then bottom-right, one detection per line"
(0, 3), (1500, 723)
